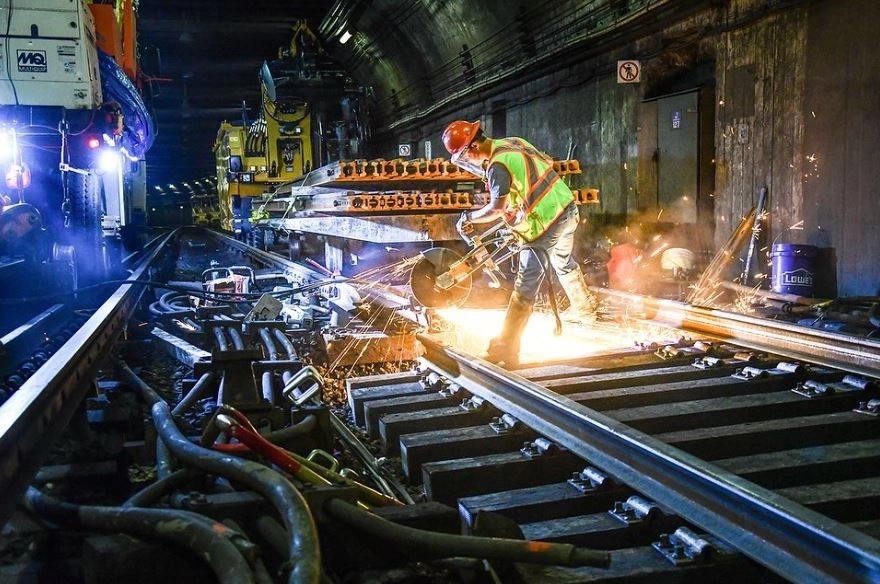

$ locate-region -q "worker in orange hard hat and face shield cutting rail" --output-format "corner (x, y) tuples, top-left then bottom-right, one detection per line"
(443, 120), (599, 369)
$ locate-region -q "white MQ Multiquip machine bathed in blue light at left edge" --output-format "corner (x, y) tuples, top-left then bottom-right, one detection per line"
(0, 0), (155, 314)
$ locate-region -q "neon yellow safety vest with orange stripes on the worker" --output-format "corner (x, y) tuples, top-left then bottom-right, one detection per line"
(489, 138), (574, 242)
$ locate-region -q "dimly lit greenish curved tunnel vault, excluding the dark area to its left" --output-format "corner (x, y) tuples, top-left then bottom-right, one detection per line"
(320, 0), (705, 131)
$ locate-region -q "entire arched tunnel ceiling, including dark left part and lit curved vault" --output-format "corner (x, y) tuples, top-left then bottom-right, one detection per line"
(138, 0), (704, 182)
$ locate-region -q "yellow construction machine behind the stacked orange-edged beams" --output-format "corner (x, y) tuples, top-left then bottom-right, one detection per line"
(214, 21), (361, 237)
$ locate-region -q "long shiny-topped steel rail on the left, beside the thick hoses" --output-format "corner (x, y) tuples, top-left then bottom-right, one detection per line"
(0, 232), (175, 525)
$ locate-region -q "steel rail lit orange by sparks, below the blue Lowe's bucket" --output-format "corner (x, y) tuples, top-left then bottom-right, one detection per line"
(596, 288), (880, 377)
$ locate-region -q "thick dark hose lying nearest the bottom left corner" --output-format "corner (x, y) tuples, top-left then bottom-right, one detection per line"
(24, 487), (254, 584)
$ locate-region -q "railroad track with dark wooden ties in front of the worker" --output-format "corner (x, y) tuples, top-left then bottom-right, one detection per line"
(349, 320), (880, 582)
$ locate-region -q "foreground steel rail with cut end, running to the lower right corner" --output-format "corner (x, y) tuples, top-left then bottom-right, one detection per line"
(419, 336), (880, 583)
